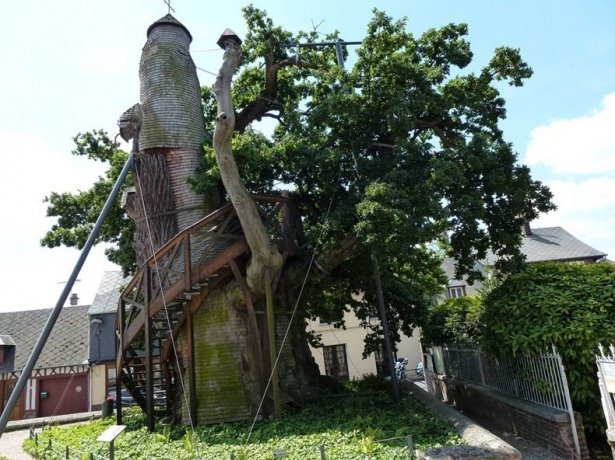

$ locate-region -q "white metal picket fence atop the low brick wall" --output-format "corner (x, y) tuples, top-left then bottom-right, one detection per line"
(443, 347), (570, 411)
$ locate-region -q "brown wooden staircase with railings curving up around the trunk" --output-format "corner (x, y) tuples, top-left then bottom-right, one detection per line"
(116, 196), (289, 429)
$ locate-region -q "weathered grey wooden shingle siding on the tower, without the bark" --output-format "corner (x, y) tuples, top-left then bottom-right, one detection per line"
(139, 15), (212, 231)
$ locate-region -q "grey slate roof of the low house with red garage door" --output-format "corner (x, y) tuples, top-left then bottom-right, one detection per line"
(0, 305), (89, 372)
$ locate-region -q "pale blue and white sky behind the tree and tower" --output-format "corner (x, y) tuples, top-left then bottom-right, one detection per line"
(0, 0), (615, 311)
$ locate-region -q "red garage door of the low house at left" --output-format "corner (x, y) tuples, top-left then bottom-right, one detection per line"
(38, 374), (88, 417)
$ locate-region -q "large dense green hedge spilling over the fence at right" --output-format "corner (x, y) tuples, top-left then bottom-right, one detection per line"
(483, 263), (615, 432)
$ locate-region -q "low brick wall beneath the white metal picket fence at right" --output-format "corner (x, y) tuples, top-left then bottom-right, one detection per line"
(446, 380), (590, 459)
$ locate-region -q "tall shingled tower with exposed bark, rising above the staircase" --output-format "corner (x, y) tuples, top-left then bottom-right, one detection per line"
(120, 14), (220, 264)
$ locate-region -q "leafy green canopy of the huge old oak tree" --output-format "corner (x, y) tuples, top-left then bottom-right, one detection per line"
(42, 6), (553, 352)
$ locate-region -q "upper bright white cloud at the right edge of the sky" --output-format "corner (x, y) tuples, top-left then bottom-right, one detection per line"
(525, 93), (615, 174)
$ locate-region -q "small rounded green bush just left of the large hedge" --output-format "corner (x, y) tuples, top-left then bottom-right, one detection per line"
(421, 296), (483, 347)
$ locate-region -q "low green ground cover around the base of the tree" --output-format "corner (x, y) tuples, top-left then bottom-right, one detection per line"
(24, 392), (462, 460)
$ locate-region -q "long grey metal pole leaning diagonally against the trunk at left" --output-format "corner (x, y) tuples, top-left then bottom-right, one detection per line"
(0, 153), (133, 437)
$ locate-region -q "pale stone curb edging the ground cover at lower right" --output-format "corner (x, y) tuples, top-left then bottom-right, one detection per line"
(409, 382), (521, 460)
